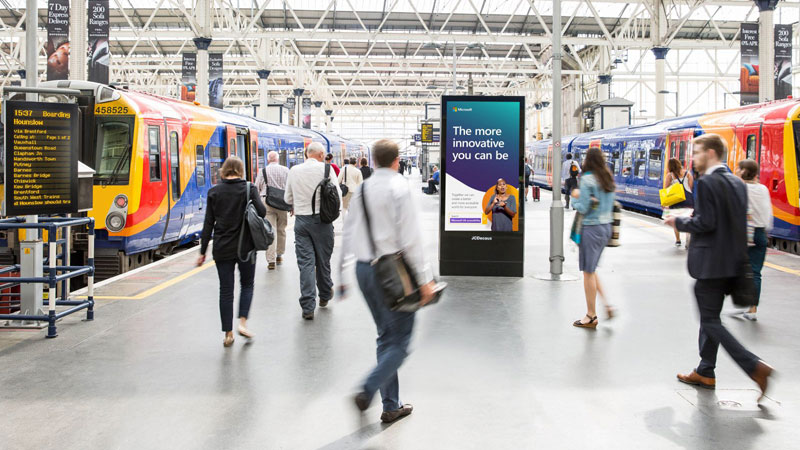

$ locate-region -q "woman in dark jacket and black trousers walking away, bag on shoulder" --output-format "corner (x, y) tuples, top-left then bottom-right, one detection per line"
(197, 156), (267, 347)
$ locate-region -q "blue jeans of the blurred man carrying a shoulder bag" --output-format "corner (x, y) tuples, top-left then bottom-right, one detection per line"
(356, 261), (414, 411)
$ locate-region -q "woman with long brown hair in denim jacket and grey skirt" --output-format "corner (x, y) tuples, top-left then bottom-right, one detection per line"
(572, 148), (616, 328)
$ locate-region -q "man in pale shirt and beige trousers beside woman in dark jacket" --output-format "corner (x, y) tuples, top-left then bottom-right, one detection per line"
(256, 151), (289, 270)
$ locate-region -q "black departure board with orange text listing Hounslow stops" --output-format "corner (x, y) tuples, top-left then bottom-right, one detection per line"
(4, 101), (79, 216)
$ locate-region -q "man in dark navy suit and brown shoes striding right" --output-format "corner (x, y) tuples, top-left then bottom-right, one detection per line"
(664, 134), (772, 400)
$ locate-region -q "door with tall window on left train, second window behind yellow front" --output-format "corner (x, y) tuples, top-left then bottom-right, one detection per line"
(163, 119), (186, 241)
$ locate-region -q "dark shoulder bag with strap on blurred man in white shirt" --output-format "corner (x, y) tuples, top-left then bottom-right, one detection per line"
(361, 184), (420, 311)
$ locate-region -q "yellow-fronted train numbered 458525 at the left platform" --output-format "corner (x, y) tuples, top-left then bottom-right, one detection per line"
(1, 80), (371, 280)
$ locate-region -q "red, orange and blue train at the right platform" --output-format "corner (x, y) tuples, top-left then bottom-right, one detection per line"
(526, 98), (800, 254)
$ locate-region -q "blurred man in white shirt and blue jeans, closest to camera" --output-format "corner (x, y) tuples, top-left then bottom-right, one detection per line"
(342, 139), (434, 423)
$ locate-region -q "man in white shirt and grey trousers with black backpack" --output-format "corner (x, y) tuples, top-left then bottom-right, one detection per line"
(284, 142), (342, 320)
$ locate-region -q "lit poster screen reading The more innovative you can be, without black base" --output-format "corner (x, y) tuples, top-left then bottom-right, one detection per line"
(442, 97), (524, 232)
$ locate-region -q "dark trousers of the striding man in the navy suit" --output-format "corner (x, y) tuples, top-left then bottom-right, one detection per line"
(694, 278), (758, 378)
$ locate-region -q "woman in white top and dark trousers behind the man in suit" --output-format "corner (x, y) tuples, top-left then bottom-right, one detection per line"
(736, 159), (773, 321)
